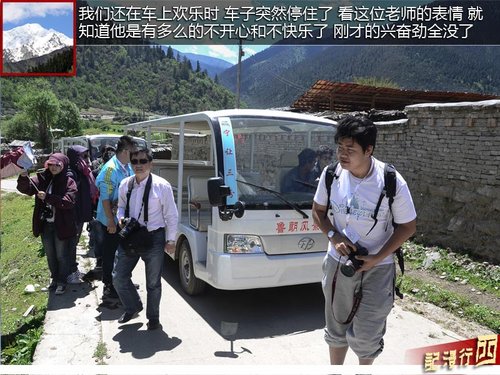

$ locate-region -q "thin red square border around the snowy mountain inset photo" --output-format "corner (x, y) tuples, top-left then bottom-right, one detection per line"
(0, 0), (77, 77)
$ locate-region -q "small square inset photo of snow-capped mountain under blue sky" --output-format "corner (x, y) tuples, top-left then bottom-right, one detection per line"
(2, 1), (75, 75)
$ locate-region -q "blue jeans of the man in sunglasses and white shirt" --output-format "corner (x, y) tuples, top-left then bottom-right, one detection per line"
(113, 229), (165, 319)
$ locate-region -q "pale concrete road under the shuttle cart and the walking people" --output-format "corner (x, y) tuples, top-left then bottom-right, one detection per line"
(29, 241), (466, 365)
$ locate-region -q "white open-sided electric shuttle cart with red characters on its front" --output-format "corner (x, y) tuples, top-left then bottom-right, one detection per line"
(127, 110), (336, 295)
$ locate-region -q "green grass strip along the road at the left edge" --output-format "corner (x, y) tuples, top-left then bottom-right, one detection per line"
(0, 193), (49, 364)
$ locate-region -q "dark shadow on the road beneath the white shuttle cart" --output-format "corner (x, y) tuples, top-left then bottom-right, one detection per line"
(163, 257), (325, 340)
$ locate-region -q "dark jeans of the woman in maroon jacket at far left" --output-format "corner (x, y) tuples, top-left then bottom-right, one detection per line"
(41, 223), (74, 285)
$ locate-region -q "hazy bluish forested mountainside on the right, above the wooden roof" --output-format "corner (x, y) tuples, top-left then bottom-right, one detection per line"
(220, 46), (500, 108)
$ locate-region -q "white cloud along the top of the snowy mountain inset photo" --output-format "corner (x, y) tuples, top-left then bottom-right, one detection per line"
(3, 2), (73, 24)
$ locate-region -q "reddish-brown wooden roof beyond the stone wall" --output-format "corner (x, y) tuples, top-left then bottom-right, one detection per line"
(292, 80), (500, 112)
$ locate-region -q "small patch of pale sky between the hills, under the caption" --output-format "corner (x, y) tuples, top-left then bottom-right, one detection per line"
(172, 44), (269, 64)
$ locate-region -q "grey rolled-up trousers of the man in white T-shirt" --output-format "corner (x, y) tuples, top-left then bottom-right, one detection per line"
(322, 254), (396, 358)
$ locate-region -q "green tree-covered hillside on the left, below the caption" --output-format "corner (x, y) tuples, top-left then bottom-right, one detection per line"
(2, 46), (235, 115)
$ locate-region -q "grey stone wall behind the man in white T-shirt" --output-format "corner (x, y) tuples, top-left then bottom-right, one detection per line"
(375, 100), (500, 263)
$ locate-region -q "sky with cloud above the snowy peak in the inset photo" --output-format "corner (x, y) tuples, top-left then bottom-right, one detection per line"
(3, 1), (73, 38)
